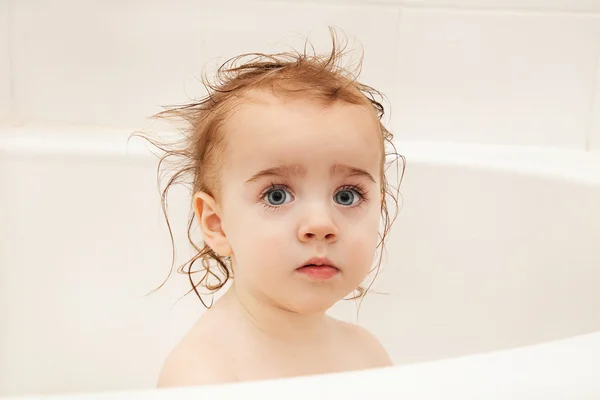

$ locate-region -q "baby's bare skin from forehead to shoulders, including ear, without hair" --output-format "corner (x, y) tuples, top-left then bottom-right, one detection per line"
(158, 92), (392, 387)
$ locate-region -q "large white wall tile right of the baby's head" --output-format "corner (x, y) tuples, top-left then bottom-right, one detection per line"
(394, 9), (600, 148)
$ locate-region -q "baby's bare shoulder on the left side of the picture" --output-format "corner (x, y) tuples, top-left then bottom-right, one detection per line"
(157, 312), (237, 388)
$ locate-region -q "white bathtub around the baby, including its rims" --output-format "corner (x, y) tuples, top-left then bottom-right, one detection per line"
(0, 127), (600, 399)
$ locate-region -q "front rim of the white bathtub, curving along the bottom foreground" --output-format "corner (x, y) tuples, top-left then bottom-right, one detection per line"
(2, 331), (600, 400)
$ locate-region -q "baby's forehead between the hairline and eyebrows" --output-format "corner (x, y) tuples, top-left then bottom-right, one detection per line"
(224, 93), (382, 180)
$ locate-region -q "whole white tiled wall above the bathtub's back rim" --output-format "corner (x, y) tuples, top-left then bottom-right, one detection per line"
(0, 0), (600, 149)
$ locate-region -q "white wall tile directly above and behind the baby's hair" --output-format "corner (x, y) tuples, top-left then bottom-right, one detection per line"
(202, 1), (400, 128)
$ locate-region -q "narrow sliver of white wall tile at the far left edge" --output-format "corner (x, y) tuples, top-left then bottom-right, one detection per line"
(0, 0), (12, 123)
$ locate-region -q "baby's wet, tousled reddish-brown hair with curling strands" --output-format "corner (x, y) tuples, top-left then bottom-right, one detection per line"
(132, 28), (405, 308)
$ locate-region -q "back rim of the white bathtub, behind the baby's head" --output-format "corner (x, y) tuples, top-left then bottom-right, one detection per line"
(0, 126), (600, 186)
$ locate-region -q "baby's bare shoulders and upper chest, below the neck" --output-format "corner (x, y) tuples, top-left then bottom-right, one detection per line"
(158, 288), (392, 387)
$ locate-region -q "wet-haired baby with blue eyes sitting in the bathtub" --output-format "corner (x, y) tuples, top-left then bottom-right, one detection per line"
(145, 29), (404, 387)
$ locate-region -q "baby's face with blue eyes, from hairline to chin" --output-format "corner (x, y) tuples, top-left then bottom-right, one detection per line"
(221, 93), (382, 312)
